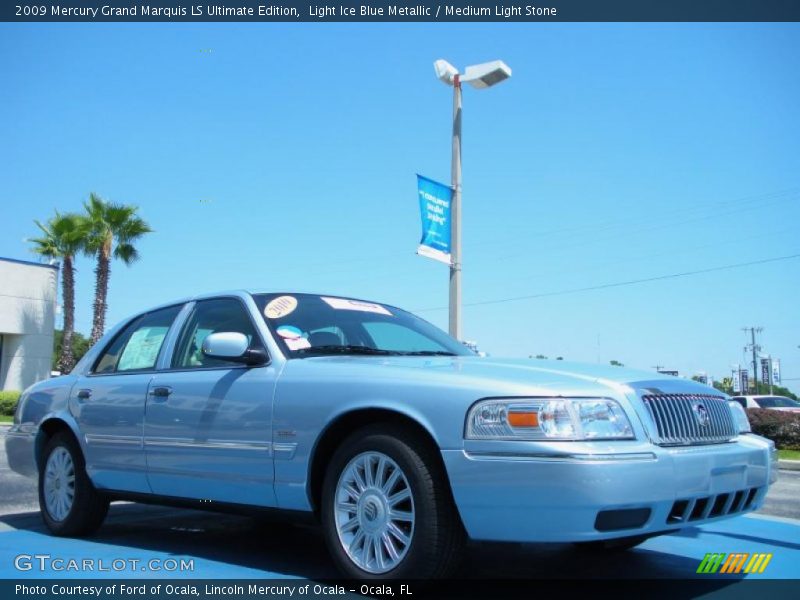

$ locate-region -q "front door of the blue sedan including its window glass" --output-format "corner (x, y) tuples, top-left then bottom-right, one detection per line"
(144, 297), (276, 506)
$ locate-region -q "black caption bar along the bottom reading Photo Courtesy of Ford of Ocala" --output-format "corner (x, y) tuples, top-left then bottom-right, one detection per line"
(0, 573), (797, 600)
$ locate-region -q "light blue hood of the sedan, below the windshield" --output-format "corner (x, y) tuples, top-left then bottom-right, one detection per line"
(291, 356), (719, 395)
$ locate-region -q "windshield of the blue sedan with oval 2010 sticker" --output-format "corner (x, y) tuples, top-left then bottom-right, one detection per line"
(253, 294), (474, 358)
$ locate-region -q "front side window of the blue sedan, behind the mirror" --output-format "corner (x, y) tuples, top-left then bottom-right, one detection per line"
(172, 298), (261, 369)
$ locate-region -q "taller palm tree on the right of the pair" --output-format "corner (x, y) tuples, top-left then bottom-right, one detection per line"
(83, 194), (152, 344)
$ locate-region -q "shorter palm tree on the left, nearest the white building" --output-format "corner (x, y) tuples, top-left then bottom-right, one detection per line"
(28, 211), (87, 373)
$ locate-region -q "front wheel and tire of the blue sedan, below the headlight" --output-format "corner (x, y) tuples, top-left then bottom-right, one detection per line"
(321, 425), (466, 579)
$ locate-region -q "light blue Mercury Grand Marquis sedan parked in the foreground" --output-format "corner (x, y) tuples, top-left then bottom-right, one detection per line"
(6, 292), (777, 578)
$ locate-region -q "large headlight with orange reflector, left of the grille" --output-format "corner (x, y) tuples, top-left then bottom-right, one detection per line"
(466, 398), (634, 440)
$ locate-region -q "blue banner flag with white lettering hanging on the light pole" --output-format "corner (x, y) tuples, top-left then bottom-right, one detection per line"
(417, 175), (453, 265)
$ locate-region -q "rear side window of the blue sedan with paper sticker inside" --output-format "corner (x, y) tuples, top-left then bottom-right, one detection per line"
(93, 306), (181, 374)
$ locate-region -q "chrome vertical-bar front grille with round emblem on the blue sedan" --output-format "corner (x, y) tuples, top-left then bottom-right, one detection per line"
(642, 394), (737, 446)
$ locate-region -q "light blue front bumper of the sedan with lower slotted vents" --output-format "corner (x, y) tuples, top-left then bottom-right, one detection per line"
(442, 435), (777, 542)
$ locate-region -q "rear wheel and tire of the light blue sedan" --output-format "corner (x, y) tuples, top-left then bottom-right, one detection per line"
(39, 432), (108, 536)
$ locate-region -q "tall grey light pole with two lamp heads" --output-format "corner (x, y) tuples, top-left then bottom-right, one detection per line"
(433, 59), (511, 340)
